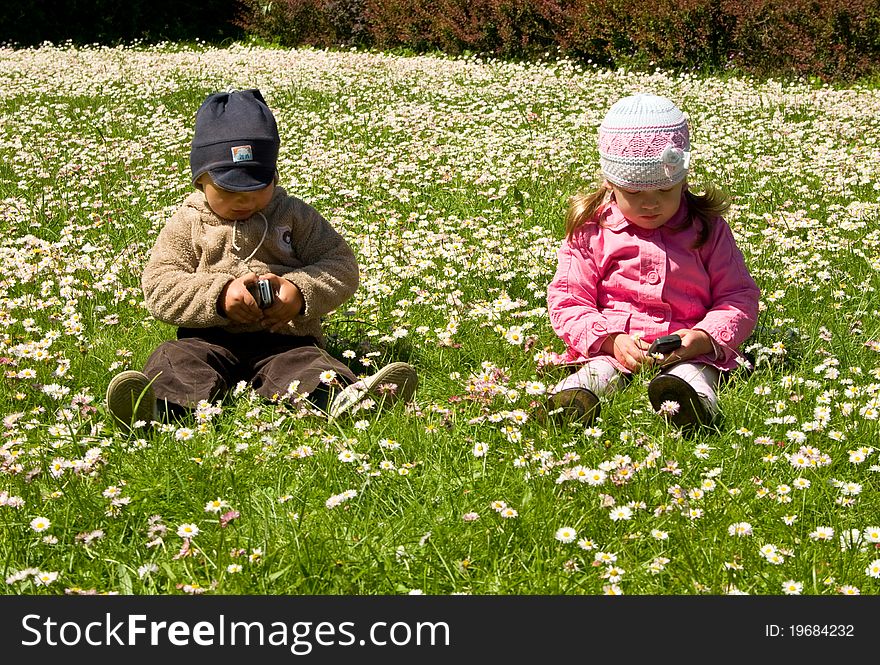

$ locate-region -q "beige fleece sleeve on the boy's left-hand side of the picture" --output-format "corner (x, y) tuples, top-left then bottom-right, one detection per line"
(141, 206), (235, 328)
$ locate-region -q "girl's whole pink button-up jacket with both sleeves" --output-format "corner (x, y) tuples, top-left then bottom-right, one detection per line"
(547, 198), (760, 371)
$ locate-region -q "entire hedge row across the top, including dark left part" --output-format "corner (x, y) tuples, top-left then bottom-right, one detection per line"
(6, 0), (880, 82)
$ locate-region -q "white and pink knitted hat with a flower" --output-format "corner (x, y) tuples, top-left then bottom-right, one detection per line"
(599, 94), (691, 190)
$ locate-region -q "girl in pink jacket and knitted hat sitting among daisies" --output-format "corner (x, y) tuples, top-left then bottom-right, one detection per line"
(547, 94), (759, 427)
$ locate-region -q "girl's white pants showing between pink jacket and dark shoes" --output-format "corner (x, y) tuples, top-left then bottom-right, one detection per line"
(550, 358), (721, 414)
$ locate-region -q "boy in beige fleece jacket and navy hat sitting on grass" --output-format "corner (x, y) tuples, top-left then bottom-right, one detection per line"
(106, 90), (418, 428)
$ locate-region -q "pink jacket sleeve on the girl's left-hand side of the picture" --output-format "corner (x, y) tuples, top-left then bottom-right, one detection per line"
(547, 226), (626, 357)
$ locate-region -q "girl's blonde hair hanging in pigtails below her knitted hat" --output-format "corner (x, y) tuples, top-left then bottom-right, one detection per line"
(565, 183), (730, 249)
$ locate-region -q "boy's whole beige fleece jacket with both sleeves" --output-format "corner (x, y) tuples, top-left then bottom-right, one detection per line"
(141, 187), (359, 345)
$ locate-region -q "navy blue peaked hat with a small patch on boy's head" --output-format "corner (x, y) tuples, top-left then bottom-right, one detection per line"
(189, 90), (281, 192)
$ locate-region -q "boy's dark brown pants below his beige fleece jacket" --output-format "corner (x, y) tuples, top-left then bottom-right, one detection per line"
(144, 328), (357, 411)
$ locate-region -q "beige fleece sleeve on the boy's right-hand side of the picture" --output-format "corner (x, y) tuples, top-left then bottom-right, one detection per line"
(279, 201), (360, 319)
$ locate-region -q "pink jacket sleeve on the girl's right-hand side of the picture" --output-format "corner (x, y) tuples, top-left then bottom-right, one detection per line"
(694, 218), (760, 361)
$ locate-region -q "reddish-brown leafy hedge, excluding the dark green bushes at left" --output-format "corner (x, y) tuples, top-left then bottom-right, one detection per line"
(238, 0), (880, 81)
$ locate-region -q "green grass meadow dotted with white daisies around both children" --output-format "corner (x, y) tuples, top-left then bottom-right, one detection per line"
(0, 45), (880, 595)
